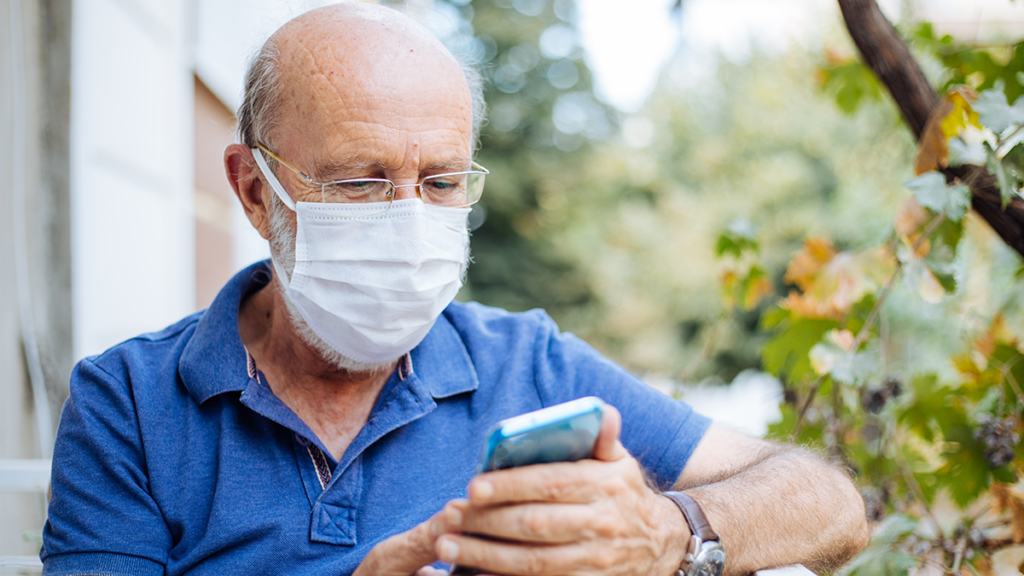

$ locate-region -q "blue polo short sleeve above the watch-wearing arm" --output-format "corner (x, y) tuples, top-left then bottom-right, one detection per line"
(534, 313), (711, 490)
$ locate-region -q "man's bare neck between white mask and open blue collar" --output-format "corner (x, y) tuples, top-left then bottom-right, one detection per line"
(239, 279), (395, 460)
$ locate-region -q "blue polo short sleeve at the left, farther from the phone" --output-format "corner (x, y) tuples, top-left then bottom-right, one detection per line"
(40, 360), (172, 576)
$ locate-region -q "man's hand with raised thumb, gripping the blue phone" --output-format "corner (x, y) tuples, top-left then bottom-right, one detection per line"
(436, 407), (690, 576)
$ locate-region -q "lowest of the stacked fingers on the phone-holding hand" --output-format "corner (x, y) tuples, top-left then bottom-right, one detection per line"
(437, 534), (612, 576)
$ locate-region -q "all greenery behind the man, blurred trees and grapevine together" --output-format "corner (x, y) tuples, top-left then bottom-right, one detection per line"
(448, 0), (1024, 574)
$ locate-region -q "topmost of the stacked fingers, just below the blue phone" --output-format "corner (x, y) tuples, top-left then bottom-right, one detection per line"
(466, 460), (610, 506)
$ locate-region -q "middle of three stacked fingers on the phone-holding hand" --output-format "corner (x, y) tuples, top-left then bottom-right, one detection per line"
(444, 502), (602, 544)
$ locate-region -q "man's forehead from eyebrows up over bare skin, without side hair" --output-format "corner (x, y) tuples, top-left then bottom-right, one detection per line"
(274, 10), (472, 168)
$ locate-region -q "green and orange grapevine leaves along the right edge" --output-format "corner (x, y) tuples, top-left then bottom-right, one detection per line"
(763, 15), (1024, 575)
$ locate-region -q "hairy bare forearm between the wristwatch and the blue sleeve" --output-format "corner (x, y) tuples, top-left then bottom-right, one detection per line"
(676, 444), (868, 574)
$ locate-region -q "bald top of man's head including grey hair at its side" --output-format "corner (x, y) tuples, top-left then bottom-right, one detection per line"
(239, 3), (483, 158)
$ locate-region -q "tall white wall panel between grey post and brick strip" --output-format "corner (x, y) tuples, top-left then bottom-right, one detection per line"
(71, 0), (195, 358)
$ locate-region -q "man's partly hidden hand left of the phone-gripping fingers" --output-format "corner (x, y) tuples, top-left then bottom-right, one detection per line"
(352, 512), (451, 576)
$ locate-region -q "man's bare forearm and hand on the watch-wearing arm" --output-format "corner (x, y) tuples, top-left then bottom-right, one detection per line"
(436, 409), (867, 576)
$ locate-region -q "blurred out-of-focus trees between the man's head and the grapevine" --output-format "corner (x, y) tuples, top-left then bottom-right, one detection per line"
(438, 0), (913, 381)
